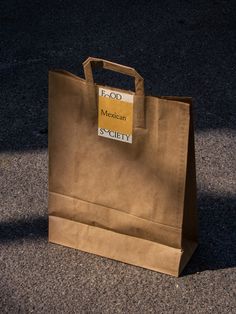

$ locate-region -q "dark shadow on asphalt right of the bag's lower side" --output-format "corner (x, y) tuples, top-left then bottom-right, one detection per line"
(183, 195), (236, 276)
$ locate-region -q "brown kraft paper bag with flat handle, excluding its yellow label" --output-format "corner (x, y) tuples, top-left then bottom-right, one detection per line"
(49, 58), (197, 276)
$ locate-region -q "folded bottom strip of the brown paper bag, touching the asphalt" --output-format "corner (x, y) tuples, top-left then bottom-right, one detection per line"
(48, 216), (197, 277)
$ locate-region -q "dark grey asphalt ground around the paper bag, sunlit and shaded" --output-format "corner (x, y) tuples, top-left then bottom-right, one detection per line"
(0, 0), (236, 314)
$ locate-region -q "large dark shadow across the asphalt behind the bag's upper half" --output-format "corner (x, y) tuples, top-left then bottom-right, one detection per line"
(0, 0), (236, 150)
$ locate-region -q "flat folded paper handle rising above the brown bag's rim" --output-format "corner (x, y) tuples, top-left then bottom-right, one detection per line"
(83, 57), (144, 96)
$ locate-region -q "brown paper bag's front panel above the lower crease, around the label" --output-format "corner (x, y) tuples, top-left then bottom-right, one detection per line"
(49, 73), (189, 242)
